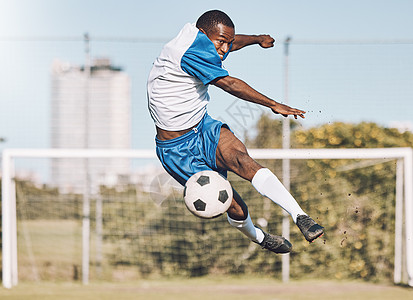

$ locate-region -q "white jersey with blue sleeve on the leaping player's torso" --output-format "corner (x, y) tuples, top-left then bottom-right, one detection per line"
(147, 24), (229, 131)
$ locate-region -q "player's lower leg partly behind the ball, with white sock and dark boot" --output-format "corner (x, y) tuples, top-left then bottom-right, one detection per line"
(227, 189), (292, 253)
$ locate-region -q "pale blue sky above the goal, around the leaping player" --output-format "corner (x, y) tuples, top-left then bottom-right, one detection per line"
(0, 0), (413, 149)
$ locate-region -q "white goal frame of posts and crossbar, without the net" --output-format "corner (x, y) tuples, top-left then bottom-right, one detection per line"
(2, 148), (413, 288)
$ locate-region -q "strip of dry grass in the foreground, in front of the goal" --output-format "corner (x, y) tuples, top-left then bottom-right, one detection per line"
(0, 277), (413, 300)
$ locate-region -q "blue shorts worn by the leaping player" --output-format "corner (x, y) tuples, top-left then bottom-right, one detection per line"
(155, 114), (229, 185)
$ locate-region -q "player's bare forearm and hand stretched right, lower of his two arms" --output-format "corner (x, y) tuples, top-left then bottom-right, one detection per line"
(211, 76), (305, 119)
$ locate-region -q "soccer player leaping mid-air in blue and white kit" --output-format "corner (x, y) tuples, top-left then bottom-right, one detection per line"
(147, 10), (323, 253)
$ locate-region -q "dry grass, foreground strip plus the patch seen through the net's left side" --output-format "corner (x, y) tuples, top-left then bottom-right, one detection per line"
(9, 220), (413, 300)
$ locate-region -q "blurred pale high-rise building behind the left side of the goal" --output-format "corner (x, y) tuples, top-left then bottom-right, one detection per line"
(51, 59), (131, 191)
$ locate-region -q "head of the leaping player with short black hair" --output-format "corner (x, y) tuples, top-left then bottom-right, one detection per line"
(196, 10), (235, 60)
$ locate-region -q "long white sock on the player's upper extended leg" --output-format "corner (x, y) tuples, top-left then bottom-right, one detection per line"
(251, 168), (306, 223)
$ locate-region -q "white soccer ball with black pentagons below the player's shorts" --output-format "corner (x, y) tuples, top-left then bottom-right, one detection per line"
(184, 170), (232, 219)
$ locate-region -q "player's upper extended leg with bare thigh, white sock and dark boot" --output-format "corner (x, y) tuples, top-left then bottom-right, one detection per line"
(216, 127), (323, 241)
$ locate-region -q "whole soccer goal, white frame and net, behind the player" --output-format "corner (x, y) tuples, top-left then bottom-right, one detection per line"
(2, 148), (413, 288)
